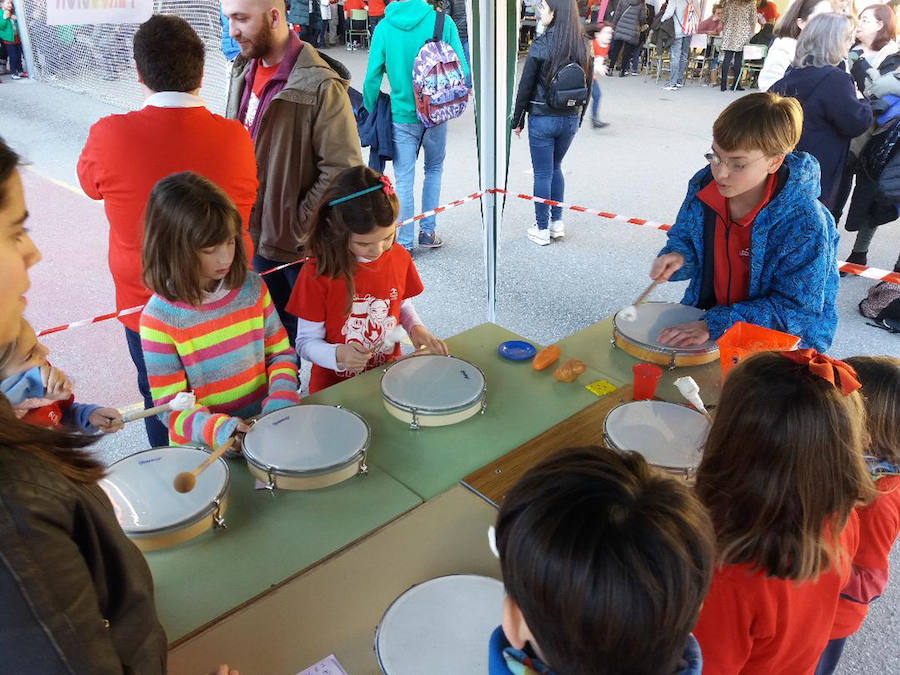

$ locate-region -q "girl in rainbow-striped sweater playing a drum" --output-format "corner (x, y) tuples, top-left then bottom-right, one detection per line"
(141, 172), (300, 447)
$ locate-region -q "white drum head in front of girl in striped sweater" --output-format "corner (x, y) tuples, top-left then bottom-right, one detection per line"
(244, 404), (369, 472)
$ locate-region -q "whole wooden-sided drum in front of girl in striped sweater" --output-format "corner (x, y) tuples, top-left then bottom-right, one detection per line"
(243, 404), (370, 490)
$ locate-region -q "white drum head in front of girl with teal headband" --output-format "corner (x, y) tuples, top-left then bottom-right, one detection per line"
(381, 354), (484, 413)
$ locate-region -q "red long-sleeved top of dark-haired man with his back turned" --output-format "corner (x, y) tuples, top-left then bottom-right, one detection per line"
(78, 99), (257, 331)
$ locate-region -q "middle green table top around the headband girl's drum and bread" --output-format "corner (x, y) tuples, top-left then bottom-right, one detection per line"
(307, 323), (608, 499)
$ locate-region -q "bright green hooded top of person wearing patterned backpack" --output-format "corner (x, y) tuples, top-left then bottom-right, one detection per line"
(363, 0), (469, 124)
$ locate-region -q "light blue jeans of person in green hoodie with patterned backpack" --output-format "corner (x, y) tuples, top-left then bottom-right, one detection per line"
(394, 122), (447, 249)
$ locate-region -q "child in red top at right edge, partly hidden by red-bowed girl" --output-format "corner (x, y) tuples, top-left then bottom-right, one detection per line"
(816, 356), (900, 675)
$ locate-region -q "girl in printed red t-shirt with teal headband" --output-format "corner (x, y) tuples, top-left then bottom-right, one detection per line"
(287, 166), (447, 393)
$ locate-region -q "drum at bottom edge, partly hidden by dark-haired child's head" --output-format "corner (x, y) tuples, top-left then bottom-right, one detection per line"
(375, 574), (504, 675)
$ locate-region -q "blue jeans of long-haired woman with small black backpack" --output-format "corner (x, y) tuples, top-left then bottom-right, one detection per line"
(528, 115), (578, 230)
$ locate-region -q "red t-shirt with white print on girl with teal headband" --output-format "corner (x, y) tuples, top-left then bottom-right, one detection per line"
(286, 245), (423, 393)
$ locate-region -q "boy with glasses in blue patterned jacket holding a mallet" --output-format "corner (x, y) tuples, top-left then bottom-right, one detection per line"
(650, 93), (839, 351)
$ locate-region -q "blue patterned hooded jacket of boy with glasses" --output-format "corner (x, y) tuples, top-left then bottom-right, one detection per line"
(660, 152), (839, 352)
